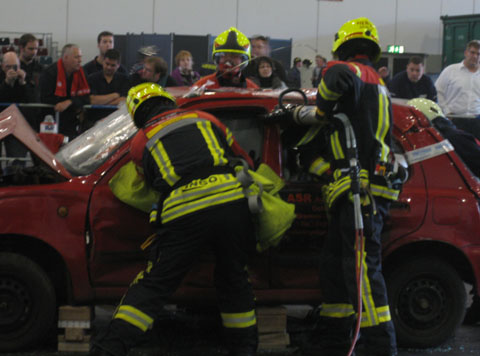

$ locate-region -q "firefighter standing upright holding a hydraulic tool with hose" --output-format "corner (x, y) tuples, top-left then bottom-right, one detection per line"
(267, 18), (401, 356)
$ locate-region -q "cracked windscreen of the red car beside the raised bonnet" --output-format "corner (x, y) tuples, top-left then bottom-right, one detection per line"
(55, 105), (137, 176)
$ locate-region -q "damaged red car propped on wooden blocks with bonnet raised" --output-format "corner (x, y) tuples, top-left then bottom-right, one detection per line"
(0, 89), (480, 352)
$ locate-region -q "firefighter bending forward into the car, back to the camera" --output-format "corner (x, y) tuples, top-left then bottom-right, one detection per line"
(92, 83), (258, 356)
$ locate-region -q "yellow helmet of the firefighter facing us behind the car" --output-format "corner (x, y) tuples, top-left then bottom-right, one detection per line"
(212, 27), (250, 63)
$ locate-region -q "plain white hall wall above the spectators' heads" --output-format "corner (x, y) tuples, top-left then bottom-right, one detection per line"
(0, 0), (480, 66)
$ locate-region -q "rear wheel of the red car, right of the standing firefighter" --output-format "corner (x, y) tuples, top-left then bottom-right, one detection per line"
(386, 258), (466, 348)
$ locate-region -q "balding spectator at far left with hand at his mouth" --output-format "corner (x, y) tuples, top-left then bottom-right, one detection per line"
(0, 52), (27, 164)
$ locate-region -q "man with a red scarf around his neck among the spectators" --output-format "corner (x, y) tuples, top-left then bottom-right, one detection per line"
(40, 43), (90, 139)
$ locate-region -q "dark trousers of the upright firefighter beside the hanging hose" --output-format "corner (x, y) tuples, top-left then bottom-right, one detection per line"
(315, 197), (397, 356)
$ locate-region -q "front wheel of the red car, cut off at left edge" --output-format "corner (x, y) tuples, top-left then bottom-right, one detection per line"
(0, 253), (56, 352)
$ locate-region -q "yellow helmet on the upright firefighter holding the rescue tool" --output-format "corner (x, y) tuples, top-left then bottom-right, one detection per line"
(332, 17), (381, 62)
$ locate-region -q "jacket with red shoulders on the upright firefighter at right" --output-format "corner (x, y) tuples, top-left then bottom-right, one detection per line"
(297, 59), (399, 208)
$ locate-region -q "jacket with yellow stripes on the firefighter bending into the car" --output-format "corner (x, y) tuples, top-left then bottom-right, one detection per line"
(131, 110), (251, 223)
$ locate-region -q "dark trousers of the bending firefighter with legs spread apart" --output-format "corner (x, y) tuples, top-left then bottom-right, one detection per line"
(93, 199), (258, 356)
